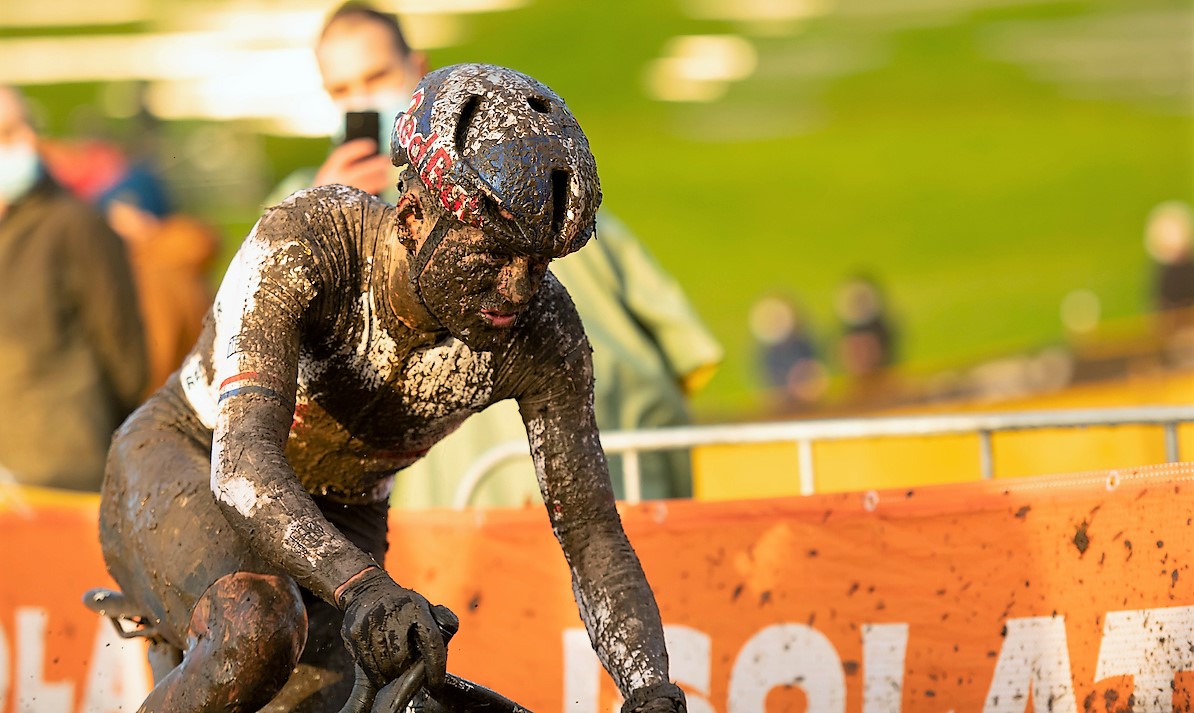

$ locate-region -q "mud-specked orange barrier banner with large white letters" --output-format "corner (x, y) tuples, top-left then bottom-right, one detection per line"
(0, 465), (1194, 713)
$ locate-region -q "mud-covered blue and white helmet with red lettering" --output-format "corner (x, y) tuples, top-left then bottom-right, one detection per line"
(390, 64), (601, 257)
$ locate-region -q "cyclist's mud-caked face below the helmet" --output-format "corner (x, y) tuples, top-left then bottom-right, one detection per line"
(419, 215), (550, 346)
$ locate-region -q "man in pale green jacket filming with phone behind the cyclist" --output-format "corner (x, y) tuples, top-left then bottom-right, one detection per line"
(282, 2), (722, 508)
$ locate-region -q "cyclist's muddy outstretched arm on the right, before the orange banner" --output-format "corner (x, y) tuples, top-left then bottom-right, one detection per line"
(519, 294), (667, 696)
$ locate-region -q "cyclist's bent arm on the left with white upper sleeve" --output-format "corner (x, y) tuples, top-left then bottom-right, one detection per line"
(204, 203), (374, 603)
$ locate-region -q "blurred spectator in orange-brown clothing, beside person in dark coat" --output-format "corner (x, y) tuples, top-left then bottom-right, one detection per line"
(97, 164), (219, 395)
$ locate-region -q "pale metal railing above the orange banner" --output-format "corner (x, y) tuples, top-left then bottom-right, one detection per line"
(453, 406), (1194, 509)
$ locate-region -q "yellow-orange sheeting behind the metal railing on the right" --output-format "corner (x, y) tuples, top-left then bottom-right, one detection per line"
(693, 371), (1194, 500)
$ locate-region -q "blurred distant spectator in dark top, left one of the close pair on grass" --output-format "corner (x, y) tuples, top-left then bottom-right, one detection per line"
(750, 290), (829, 411)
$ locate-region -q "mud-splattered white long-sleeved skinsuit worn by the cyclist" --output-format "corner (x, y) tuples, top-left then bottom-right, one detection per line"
(101, 186), (667, 695)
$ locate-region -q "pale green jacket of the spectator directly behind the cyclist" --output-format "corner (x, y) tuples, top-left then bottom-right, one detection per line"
(392, 211), (722, 508)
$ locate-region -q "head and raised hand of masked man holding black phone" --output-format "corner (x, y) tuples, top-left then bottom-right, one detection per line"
(266, 1), (427, 205)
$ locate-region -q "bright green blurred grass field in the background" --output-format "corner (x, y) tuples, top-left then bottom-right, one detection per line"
(21, 0), (1194, 419)
